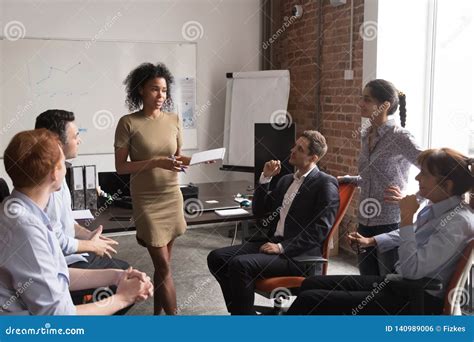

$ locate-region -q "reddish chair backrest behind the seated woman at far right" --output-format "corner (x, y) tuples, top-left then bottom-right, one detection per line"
(443, 240), (474, 315)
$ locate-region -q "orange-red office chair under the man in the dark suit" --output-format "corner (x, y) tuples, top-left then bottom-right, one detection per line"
(254, 183), (356, 314)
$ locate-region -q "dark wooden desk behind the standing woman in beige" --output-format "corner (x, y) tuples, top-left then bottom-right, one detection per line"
(78, 181), (255, 243)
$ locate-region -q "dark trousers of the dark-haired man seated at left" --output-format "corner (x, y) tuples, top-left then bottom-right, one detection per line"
(68, 253), (129, 305)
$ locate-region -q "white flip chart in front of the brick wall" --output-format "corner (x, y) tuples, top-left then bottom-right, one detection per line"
(224, 70), (292, 167)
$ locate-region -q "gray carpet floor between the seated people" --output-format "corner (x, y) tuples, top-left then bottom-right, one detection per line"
(108, 226), (358, 315)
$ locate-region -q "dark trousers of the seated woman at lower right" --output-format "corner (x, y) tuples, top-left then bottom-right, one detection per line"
(288, 275), (443, 315)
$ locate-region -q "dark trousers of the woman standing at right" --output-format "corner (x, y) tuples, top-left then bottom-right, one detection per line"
(357, 223), (399, 276)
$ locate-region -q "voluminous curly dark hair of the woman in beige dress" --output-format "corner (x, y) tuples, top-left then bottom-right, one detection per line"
(123, 63), (174, 111)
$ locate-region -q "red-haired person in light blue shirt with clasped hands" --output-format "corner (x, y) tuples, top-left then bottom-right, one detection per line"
(0, 129), (153, 315)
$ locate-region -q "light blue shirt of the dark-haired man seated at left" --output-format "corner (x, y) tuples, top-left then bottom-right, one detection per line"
(45, 180), (87, 265)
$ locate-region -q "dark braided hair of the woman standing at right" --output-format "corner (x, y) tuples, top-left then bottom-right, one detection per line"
(366, 79), (407, 127)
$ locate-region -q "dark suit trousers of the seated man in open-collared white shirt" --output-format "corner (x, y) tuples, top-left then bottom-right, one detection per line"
(207, 242), (304, 315)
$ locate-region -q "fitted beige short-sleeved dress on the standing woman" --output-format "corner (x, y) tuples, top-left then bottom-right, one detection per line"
(114, 111), (186, 247)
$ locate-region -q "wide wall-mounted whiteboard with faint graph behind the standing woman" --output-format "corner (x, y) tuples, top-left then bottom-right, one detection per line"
(0, 39), (197, 155)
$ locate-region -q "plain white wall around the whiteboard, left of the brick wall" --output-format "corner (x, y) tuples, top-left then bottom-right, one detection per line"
(0, 0), (261, 187)
